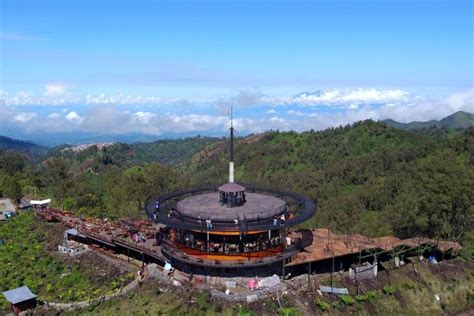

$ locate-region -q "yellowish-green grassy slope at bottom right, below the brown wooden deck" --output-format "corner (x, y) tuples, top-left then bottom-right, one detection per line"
(306, 259), (474, 315)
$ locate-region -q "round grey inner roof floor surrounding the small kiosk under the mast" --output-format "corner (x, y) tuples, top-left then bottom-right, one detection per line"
(176, 192), (287, 222)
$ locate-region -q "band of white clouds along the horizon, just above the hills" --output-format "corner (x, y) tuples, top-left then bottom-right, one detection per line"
(0, 84), (474, 141)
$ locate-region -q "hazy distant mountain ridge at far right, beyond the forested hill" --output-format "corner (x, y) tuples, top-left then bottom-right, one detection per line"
(382, 111), (474, 130)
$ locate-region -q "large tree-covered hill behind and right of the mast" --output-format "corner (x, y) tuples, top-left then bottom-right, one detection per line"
(185, 121), (474, 247)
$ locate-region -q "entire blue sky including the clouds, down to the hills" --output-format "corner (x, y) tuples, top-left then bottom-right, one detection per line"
(0, 0), (474, 144)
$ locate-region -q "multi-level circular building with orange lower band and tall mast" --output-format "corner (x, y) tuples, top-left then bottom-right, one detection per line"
(146, 117), (315, 276)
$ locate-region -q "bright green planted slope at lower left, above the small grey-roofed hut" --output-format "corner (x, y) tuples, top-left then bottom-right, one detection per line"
(0, 211), (133, 312)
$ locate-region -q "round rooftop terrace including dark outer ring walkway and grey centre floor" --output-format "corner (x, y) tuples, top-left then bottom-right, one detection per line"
(145, 187), (316, 232)
